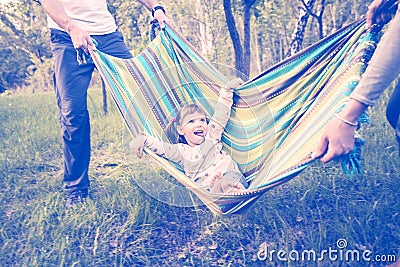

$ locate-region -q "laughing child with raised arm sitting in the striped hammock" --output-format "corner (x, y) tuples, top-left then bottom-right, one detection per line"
(130, 78), (247, 193)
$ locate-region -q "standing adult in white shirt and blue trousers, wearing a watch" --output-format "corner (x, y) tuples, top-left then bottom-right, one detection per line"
(41, 0), (167, 207)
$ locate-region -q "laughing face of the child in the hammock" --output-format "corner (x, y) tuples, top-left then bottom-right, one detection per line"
(178, 112), (208, 149)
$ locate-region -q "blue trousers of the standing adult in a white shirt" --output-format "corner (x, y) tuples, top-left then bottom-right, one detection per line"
(50, 29), (132, 192)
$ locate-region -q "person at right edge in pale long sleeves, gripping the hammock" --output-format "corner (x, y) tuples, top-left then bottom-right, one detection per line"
(313, 0), (400, 162)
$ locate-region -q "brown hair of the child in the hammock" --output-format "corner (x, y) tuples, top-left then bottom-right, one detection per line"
(164, 104), (206, 144)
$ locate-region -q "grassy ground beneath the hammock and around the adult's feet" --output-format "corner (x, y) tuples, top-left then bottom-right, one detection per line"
(0, 89), (400, 266)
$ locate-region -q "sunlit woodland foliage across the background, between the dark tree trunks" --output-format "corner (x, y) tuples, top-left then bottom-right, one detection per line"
(0, 0), (376, 90)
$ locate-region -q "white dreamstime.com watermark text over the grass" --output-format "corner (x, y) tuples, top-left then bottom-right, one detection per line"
(257, 238), (396, 263)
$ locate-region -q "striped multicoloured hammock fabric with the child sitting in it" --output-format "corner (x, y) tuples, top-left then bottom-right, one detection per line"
(92, 20), (378, 214)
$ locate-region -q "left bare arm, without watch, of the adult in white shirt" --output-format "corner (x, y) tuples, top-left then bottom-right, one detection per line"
(40, 0), (95, 53)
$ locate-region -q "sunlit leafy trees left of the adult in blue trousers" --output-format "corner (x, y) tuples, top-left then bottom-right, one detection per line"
(0, 0), (51, 92)
